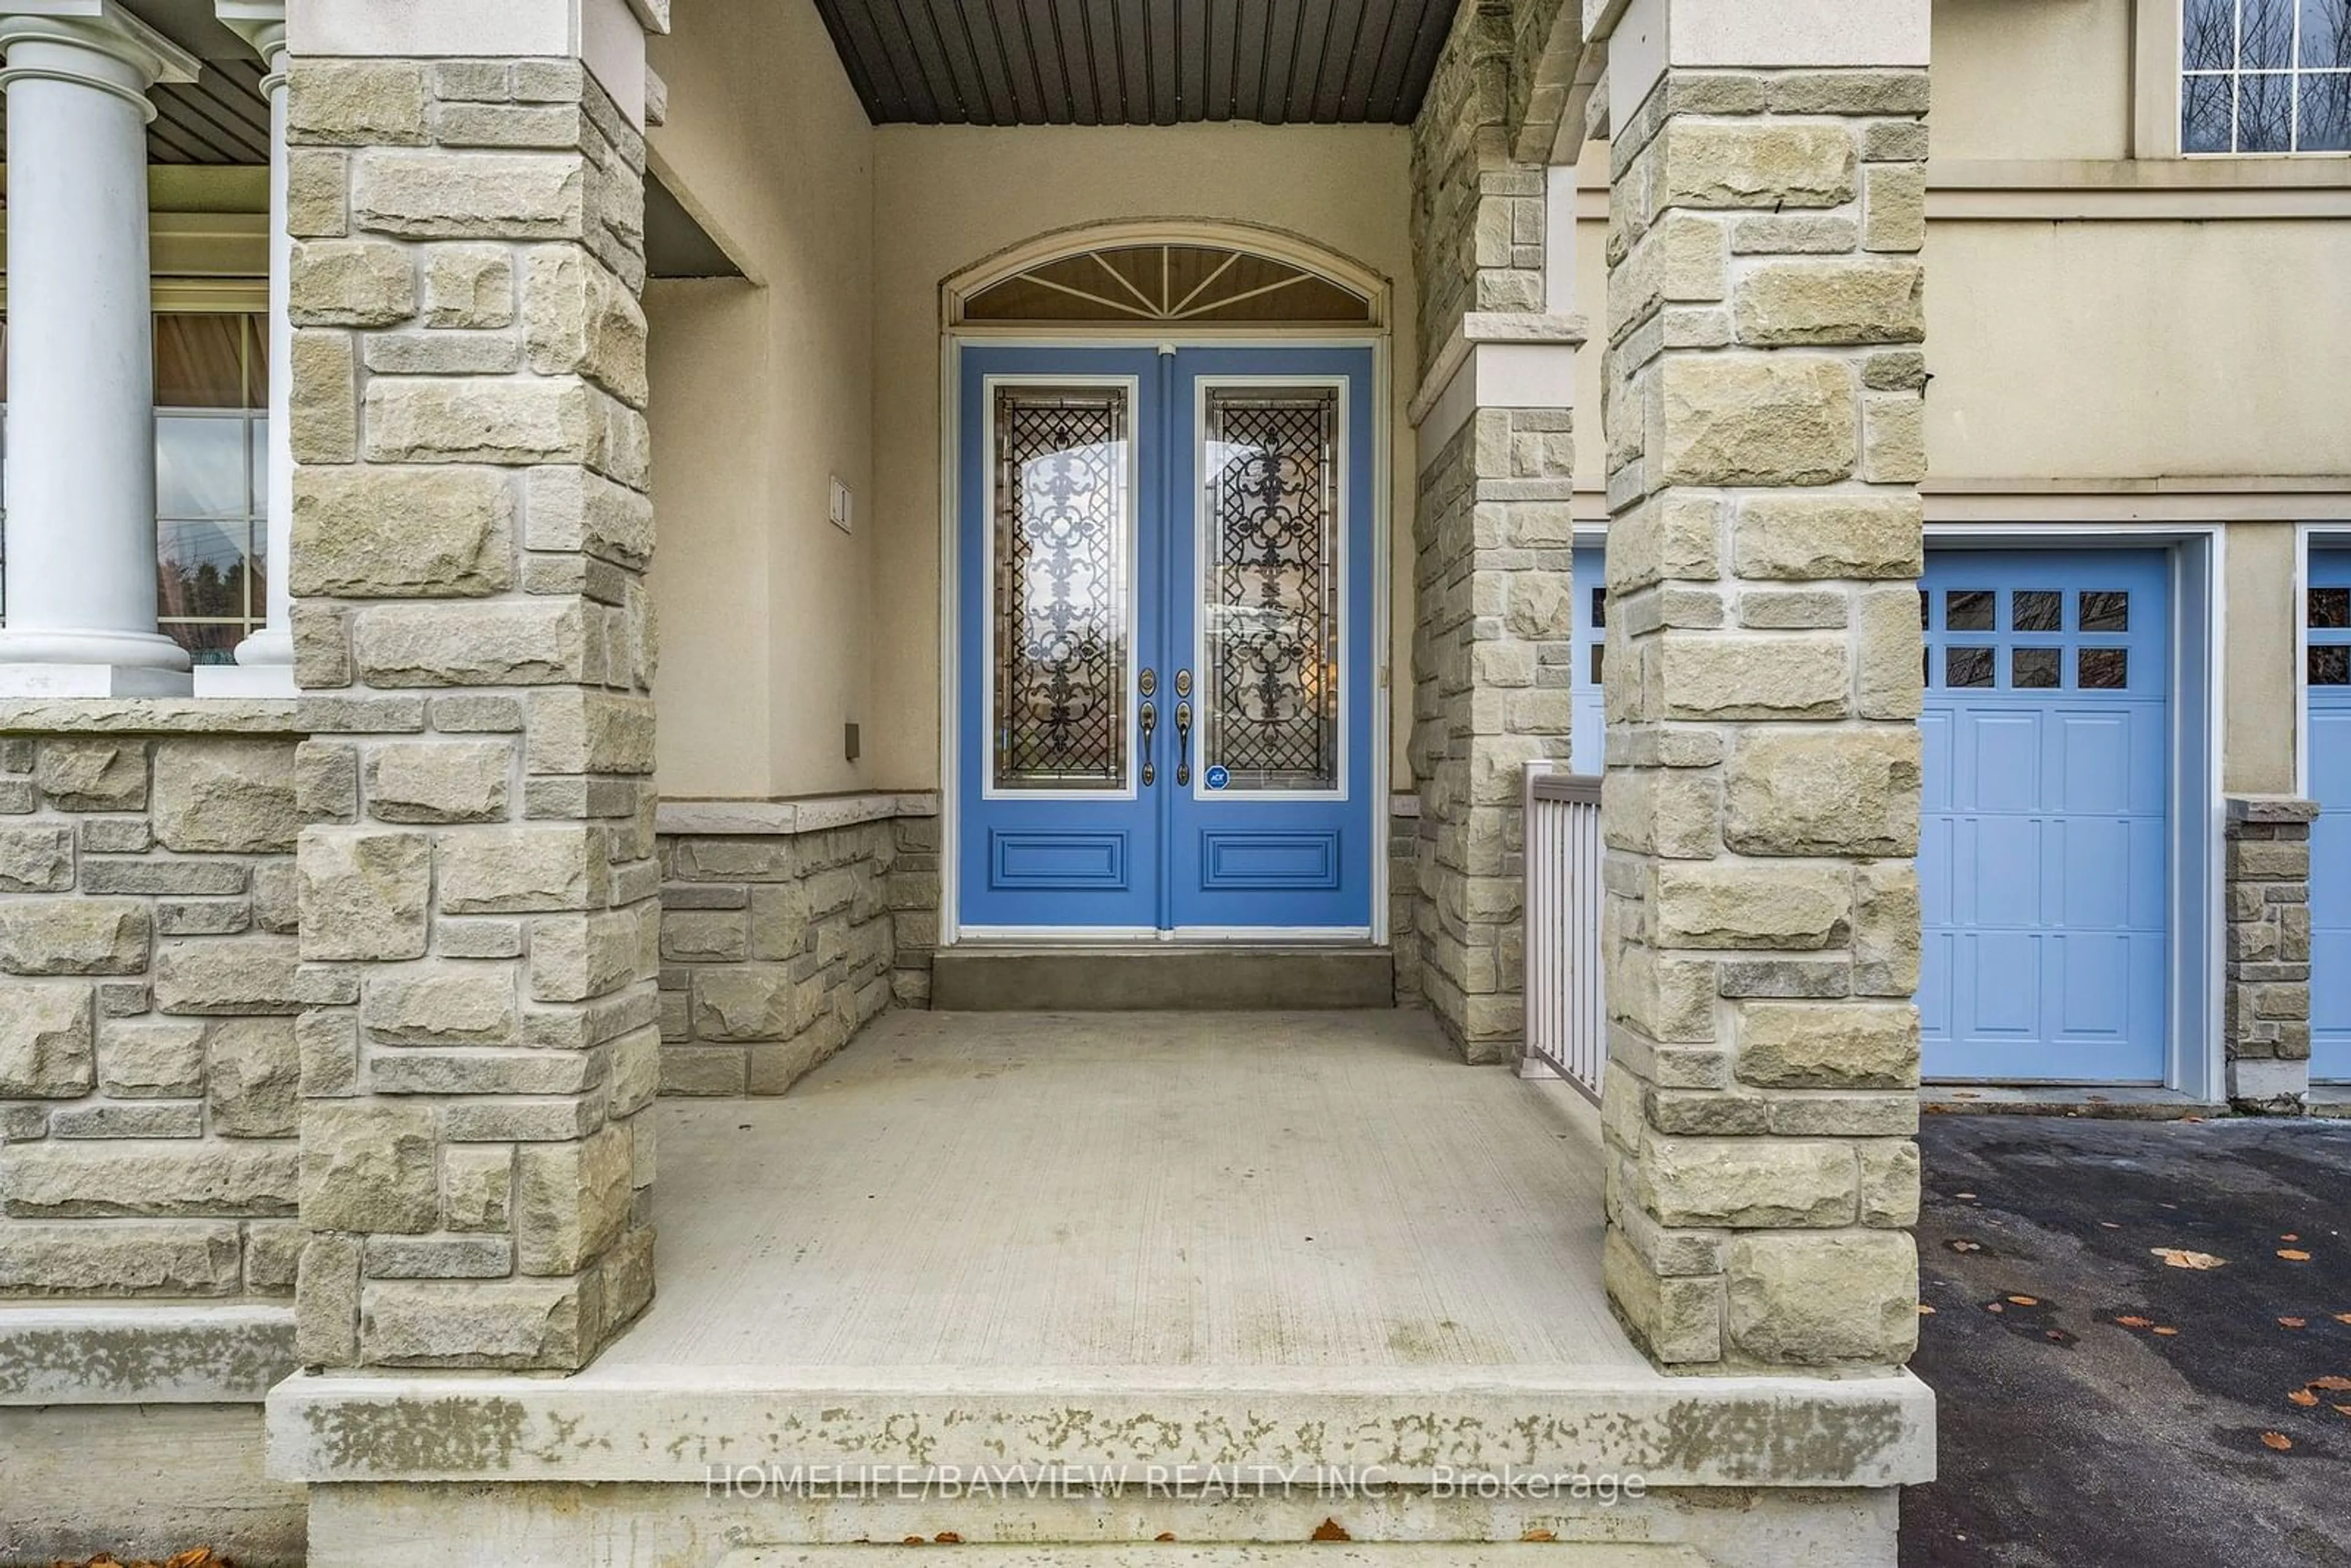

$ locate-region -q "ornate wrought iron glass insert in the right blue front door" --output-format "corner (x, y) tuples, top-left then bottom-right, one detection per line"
(1201, 388), (1340, 790)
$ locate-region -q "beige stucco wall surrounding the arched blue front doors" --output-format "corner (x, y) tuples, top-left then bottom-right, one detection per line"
(865, 124), (1415, 787)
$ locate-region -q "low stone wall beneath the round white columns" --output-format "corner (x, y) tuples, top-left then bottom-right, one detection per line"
(0, 703), (303, 1297)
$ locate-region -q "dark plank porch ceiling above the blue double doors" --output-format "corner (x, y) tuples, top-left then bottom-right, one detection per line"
(816, 0), (1458, 124)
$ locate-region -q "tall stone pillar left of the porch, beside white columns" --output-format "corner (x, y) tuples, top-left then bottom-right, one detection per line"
(287, 49), (661, 1368)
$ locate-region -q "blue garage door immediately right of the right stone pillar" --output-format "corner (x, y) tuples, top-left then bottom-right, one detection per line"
(1918, 550), (2170, 1084)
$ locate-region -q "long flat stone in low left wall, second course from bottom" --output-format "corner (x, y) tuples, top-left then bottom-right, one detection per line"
(0, 1140), (296, 1220)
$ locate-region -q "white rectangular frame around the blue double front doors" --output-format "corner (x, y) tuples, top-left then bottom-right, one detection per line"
(938, 322), (1397, 947)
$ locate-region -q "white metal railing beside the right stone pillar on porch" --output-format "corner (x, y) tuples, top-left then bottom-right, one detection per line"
(1526, 767), (1608, 1100)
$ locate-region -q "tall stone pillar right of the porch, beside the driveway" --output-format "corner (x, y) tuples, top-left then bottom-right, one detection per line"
(1603, 0), (1928, 1370)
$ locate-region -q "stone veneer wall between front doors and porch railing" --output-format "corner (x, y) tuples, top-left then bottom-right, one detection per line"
(1399, 0), (1575, 1062)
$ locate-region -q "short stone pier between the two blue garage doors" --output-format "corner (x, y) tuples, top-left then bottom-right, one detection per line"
(2222, 795), (2318, 1117)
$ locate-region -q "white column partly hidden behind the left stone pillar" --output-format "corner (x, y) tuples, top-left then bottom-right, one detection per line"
(195, 0), (294, 696)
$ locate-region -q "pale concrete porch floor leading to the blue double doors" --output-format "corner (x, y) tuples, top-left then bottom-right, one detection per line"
(602, 1011), (1646, 1370)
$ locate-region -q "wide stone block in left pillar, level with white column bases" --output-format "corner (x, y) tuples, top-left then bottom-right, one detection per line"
(353, 599), (588, 686)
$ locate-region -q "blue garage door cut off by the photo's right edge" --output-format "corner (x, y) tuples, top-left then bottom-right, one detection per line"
(2304, 550), (2351, 1081)
